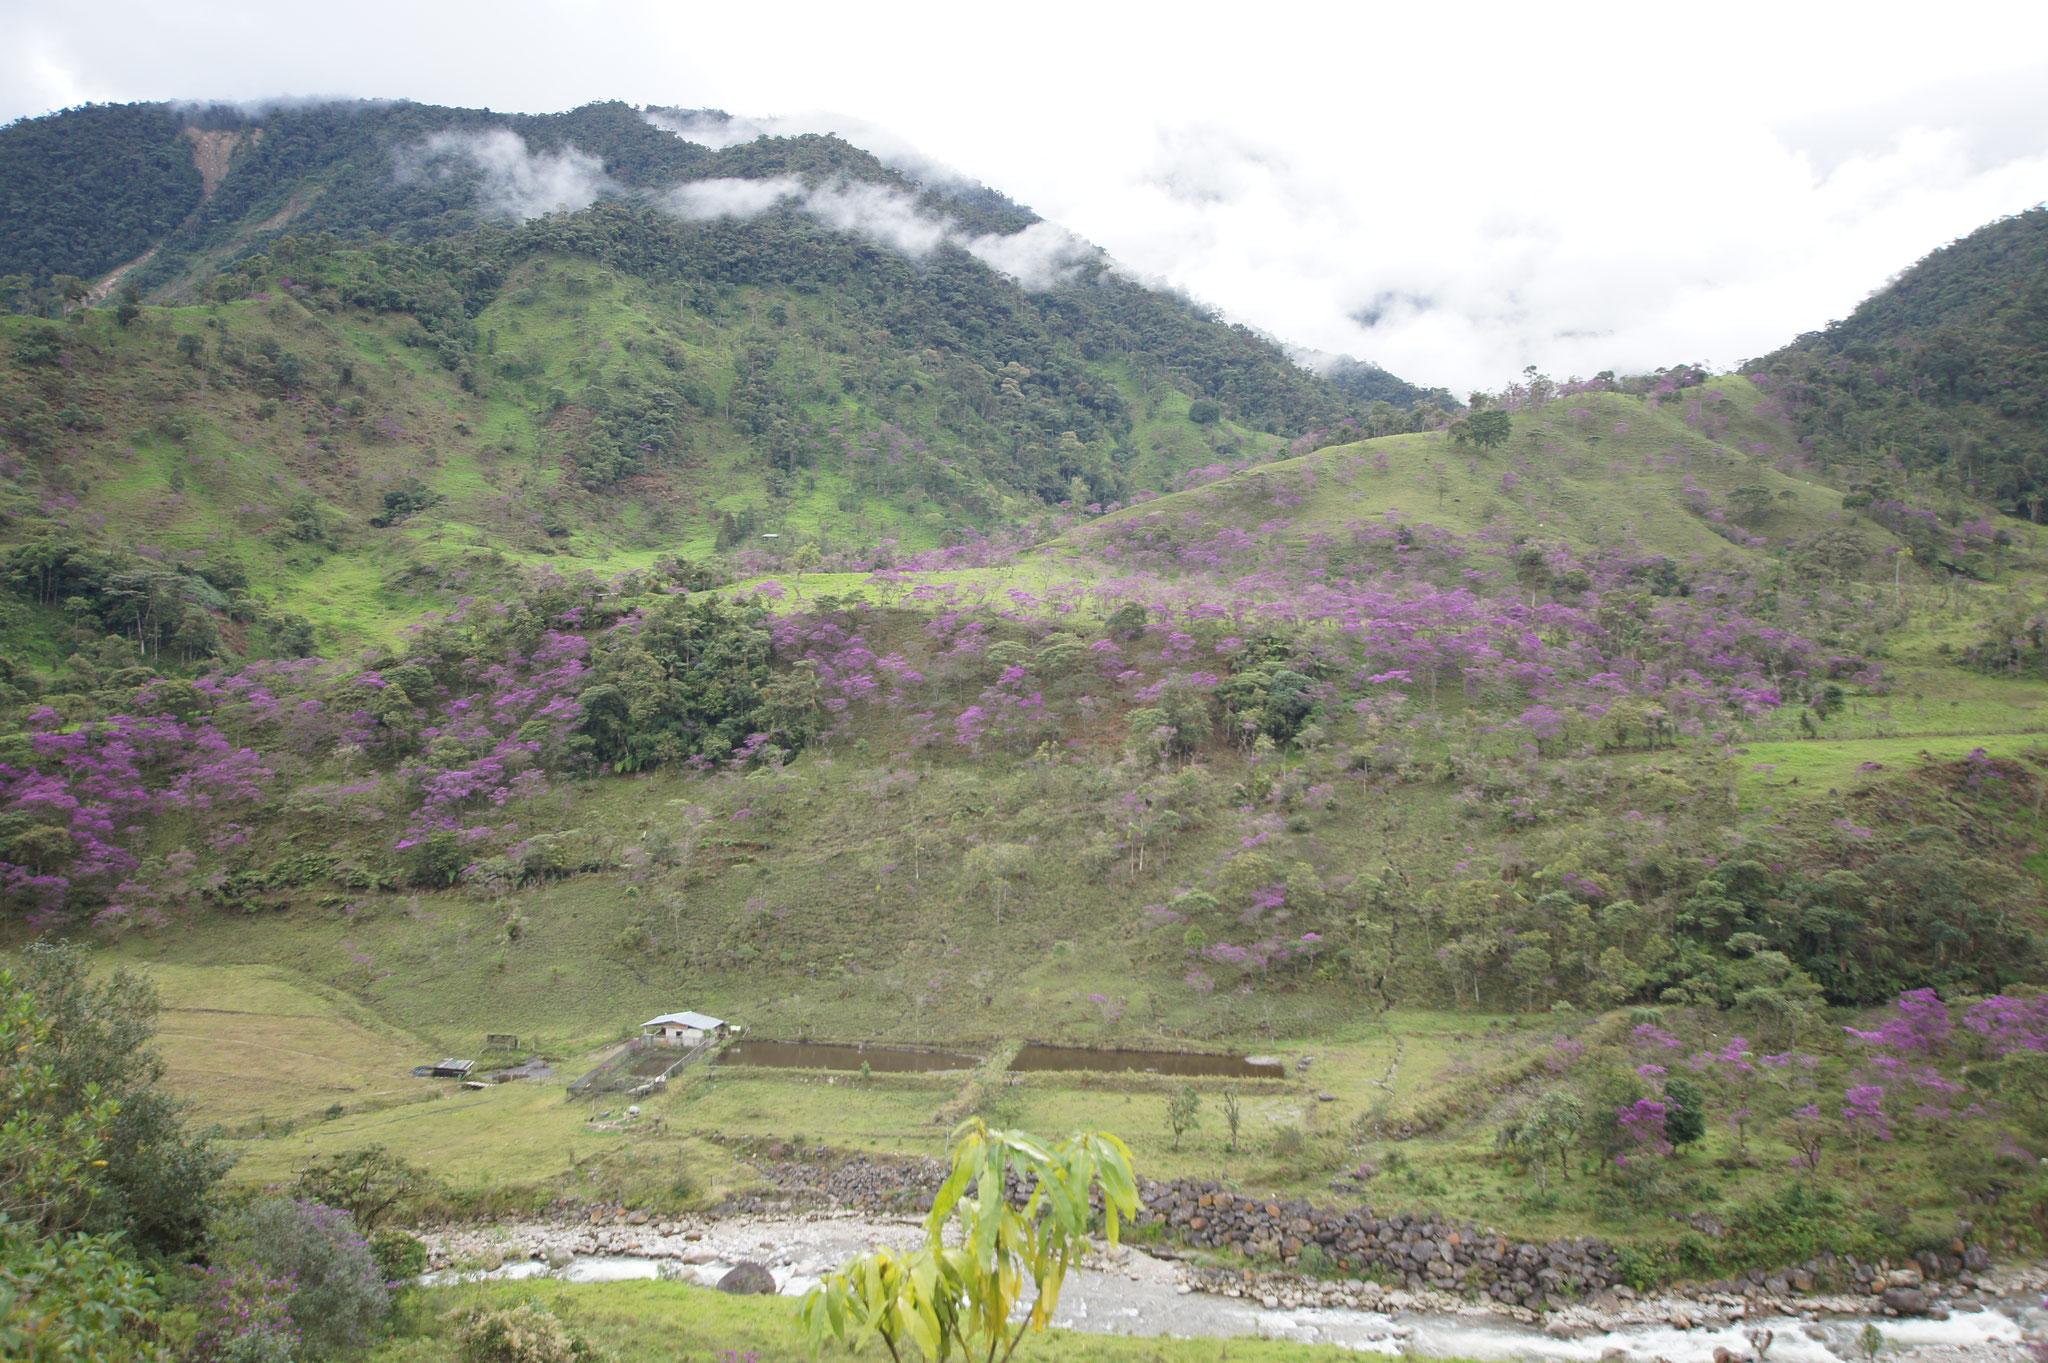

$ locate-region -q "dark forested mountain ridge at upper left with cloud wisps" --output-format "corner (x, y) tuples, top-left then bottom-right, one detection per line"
(0, 100), (1450, 409)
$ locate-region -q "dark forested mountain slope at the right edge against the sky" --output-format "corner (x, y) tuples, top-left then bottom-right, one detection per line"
(1747, 207), (2048, 522)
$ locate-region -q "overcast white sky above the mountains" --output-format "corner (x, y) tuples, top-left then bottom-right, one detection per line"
(0, 0), (2048, 393)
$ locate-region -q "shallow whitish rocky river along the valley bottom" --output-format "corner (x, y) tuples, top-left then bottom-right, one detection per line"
(422, 1203), (2048, 1363)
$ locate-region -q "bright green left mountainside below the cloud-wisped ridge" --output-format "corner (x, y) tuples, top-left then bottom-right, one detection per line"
(0, 237), (1384, 661)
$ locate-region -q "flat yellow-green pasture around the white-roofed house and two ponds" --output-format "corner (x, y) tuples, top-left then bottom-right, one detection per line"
(123, 912), (1946, 1238)
